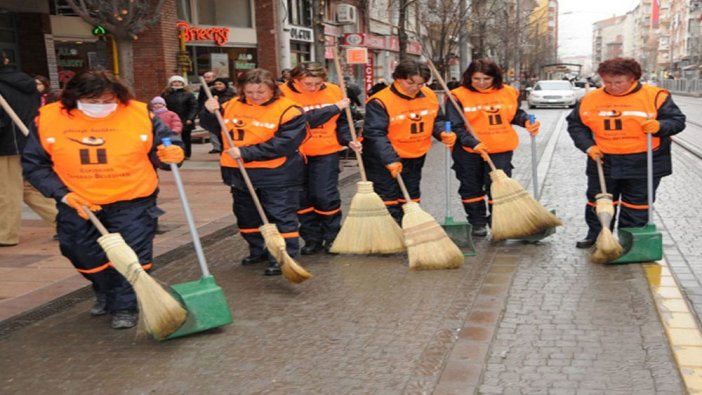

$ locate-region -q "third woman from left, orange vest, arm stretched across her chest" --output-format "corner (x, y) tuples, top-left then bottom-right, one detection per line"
(280, 62), (361, 255)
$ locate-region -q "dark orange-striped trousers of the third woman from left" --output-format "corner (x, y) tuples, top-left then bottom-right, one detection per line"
(297, 152), (341, 244)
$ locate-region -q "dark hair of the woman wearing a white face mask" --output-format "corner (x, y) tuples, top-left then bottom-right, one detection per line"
(61, 70), (134, 111)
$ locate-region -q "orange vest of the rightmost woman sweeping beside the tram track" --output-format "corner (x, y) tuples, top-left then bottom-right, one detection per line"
(579, 85), (669, 154)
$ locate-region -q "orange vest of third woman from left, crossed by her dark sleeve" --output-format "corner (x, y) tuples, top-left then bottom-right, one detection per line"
(280, 82), (344, 156)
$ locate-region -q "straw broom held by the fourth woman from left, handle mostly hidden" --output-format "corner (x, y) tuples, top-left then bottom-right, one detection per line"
(397, 174), (463, 270)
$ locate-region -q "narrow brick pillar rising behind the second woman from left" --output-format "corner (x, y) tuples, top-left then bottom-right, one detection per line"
(254, 0), (280, 77)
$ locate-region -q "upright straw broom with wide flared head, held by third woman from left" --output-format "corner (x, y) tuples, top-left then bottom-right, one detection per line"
(330, 47), (405, 254)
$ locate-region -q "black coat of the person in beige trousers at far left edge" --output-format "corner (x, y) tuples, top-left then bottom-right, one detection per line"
(0, 66), (40, 156)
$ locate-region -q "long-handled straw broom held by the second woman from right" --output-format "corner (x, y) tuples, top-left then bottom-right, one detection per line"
(427, 59), (561, 240)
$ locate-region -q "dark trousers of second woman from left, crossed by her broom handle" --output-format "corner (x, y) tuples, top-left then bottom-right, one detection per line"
(231, 187), (300, 262)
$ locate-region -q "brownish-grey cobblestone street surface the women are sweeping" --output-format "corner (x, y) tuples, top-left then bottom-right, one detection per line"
(0, 103), (700, 394)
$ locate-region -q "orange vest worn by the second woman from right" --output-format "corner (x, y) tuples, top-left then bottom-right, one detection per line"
(451, 85), (519, 154)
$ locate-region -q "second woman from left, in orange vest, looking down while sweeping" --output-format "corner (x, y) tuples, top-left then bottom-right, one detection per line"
(205, 69), (307, 276)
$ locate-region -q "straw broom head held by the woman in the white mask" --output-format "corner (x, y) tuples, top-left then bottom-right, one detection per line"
(98, 233), (187, 339)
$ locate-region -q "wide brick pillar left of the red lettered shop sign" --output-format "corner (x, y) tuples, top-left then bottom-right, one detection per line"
(134, 0), (179, 101)
